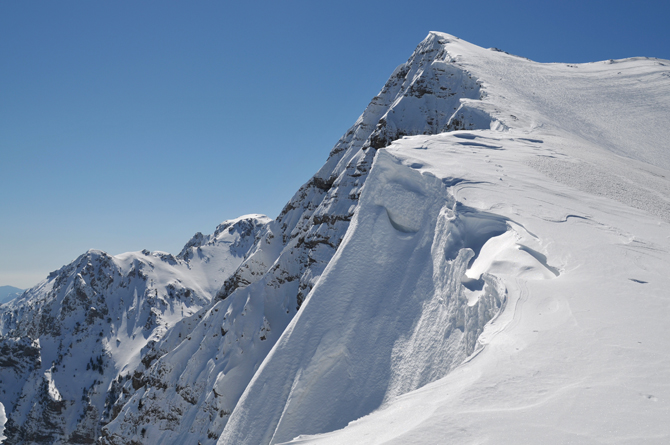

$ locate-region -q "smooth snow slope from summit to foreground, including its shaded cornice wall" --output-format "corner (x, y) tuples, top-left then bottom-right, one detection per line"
(219, 33), (670, 444)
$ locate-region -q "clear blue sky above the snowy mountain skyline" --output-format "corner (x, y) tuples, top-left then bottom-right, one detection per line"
(0, 0), (670, 288)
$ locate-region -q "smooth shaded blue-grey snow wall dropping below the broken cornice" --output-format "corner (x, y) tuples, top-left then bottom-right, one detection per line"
(219, 152), (532, 444)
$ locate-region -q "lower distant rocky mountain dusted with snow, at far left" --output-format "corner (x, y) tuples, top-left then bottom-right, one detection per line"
(0, 215), (269, 443)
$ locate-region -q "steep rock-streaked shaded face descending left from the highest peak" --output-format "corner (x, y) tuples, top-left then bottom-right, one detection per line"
(103, 30), (498, 444)
